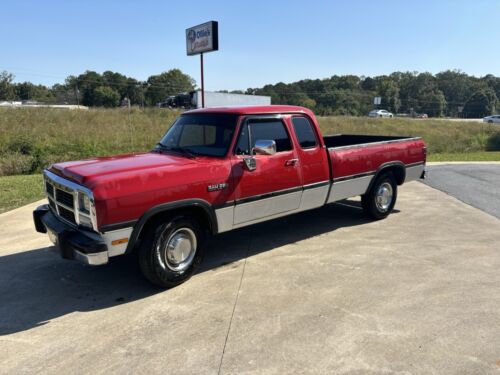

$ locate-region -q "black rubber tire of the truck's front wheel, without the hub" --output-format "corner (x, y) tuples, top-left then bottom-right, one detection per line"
(139, 215), (207, 289)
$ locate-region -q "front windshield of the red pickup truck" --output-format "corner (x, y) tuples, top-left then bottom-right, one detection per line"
(156, 113), (238, 157)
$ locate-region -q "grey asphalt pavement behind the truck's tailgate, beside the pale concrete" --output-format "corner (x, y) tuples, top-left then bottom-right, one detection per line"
(425, 163), (500, 218)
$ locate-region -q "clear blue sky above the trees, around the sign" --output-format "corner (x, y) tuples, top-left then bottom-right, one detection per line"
(0, 0), (500, 90)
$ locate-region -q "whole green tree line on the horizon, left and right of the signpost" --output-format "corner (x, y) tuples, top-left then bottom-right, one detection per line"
(0, 69), (500, 117)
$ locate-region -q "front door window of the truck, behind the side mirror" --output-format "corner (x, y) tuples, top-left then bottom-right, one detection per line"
(248, 120), (292, 152)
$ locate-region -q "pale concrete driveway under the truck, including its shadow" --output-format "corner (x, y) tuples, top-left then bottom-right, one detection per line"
(0, 183), (500, 374)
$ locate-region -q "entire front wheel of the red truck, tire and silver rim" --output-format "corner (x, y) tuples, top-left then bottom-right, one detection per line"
(139, 215), (206, 288)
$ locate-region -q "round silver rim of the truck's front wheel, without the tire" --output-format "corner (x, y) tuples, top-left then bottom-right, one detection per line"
(165, 228), (197, 272)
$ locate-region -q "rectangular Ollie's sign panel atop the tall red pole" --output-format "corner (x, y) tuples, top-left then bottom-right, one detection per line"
(186, 21), (219, 56)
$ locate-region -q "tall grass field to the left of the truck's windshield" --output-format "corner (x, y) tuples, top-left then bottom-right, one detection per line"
(0, 108), (179, 176)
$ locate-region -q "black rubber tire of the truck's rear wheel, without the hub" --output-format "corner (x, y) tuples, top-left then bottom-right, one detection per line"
(361, 173), (398, 220)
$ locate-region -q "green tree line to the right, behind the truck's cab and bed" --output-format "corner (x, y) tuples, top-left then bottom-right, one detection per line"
(246, 70), (500, 117)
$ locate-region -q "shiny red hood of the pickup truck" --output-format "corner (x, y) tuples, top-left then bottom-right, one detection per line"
(49, 152), (194, 189)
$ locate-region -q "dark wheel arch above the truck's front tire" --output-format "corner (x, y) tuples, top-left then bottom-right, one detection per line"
(127, 206), (216, 252)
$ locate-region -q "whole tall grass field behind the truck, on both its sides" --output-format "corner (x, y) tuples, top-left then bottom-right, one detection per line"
(0, 108), (500, 176)
